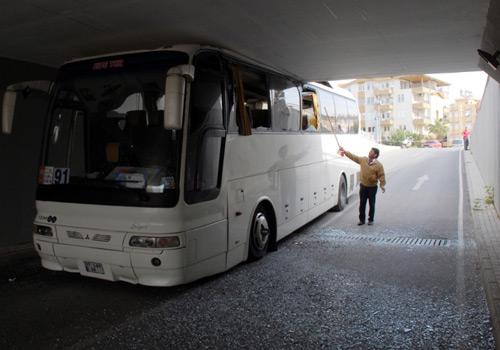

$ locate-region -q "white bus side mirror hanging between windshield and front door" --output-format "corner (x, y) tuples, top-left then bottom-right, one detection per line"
(163, 64), (194, 129)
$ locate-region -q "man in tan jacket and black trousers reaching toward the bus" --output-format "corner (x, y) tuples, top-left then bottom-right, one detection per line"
(339, 147), (385, 225)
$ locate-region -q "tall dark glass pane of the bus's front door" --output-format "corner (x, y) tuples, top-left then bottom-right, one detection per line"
(185, 53), (226, 204)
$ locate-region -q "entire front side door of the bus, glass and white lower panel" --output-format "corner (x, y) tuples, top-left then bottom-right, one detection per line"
(184, 52), (227, 268)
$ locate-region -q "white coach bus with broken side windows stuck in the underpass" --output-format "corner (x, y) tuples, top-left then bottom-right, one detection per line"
(3, 46), (359, 286)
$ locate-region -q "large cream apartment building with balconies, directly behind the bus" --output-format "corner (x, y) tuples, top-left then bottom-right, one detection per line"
(341, 75), (449, 142)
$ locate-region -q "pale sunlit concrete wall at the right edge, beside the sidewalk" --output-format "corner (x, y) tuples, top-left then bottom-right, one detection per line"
(471, 78), (500, 214)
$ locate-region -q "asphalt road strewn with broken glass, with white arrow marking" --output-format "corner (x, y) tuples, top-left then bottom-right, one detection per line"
(0, 149), (495, 349)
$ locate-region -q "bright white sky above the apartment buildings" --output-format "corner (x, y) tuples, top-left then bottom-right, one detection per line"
(331, 71), (488, 99)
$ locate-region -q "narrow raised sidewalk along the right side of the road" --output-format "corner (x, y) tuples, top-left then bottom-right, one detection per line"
(464, 151), (500, 349)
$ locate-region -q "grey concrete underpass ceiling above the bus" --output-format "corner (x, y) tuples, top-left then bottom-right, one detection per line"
(0, 0), (494, 80)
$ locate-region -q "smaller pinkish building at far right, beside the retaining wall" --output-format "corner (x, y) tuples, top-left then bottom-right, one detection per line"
(445, 90), (480, 143)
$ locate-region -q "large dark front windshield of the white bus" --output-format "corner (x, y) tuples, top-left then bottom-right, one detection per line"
(38, 50), (188, 206)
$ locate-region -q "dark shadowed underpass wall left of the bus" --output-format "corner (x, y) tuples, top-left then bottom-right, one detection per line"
(0, 58), (55, 248)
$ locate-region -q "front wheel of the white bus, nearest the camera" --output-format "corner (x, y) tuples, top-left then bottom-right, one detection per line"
(248, 204), (271, 260)
